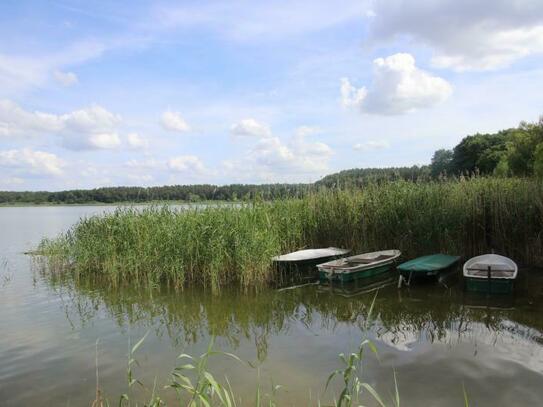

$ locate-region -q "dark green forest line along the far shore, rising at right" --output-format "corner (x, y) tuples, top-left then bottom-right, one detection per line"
(0, 116), (543, 204)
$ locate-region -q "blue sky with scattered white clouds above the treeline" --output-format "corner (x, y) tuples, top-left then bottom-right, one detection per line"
(0, 0), (543, 191)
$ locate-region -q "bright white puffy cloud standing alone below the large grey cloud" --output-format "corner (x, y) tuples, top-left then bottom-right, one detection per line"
(340, 53), (452, 115)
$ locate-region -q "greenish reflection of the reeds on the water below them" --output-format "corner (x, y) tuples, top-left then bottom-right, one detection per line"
(43, 271), (543, 352)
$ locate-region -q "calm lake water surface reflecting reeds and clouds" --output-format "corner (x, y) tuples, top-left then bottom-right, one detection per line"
(0, 206), (543, 406)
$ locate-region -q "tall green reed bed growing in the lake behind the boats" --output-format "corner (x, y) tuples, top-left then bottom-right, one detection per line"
(38, 178), (543, 290)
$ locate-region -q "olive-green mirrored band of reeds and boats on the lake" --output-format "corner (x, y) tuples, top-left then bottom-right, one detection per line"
(39, 273), (543, 362)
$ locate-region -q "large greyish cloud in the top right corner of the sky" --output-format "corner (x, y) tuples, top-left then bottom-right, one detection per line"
(371, 0), (543, 71)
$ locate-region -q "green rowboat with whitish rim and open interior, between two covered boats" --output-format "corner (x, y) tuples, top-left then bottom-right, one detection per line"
(317, 250), (402, 283)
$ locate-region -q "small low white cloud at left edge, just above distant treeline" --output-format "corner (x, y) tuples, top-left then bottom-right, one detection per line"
(0, 148), (64, 175)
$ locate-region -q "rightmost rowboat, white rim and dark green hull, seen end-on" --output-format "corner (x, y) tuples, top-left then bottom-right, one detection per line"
(464, 254), (518, 294)
